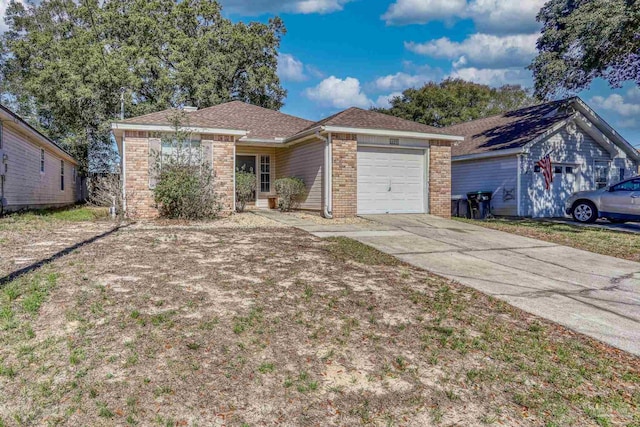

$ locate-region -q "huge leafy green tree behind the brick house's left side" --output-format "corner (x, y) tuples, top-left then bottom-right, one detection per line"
(0, 0), (286, 174)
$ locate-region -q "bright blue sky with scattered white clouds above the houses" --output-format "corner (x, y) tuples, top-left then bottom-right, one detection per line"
(0, 0), (640, 146)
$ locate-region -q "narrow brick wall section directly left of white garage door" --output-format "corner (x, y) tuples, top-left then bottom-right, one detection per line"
(332, 134), (358, 218)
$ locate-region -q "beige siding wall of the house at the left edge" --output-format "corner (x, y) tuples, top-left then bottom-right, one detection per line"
(0, 122), (80, 210)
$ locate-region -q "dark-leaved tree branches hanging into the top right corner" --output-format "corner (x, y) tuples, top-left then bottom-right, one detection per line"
(529, 0), (640, 98)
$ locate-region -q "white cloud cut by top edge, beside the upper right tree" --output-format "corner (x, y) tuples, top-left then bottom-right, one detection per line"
(382, 0), (547, 34)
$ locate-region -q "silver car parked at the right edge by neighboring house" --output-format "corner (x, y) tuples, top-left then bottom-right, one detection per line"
(565, 177), (640, 223)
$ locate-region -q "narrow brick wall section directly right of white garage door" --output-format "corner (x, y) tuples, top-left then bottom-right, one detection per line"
(429, 141), (451, 218)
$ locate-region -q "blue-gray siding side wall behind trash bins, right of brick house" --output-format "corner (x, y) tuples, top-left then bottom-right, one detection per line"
(451, 156), (518, 216)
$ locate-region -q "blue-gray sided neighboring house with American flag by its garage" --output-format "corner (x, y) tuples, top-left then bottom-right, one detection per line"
(444, 98), (640, 218)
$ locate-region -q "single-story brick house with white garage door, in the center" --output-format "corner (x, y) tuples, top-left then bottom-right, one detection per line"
(112, 101), (462, 218)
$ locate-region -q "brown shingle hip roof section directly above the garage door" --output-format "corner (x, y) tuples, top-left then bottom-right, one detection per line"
(303, 107), (455, 135)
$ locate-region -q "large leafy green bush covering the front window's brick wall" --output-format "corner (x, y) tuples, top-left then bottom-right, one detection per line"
(154, 164), (222, 220)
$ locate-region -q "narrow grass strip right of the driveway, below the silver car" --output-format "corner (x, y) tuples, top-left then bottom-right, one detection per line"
(456, 218), (640, 262)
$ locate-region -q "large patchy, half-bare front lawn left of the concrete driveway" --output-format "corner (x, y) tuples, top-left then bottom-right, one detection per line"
(0, 227), (640, 426)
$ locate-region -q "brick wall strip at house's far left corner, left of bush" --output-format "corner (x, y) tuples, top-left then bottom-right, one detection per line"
(125, 132), (158, 219)
